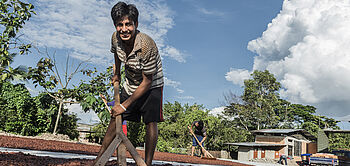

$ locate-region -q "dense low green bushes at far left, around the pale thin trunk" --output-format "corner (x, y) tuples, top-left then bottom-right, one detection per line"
(0, 82), (78, 139)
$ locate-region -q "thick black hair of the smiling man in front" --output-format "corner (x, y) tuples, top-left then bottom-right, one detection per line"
(111, 2), (139, 25)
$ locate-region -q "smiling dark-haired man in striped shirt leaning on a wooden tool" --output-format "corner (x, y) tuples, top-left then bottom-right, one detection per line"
(93, 2), (164, 165)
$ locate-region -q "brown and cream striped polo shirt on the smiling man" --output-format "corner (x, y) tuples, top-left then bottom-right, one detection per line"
(111, 31), (164, 95)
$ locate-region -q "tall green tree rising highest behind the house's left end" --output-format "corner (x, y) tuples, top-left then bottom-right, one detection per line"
(226, 70), (281, 130)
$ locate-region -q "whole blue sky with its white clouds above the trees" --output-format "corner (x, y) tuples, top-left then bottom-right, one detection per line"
(13, 0), (350, 128)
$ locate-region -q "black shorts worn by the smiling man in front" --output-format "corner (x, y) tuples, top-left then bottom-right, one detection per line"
(120, 87), (164, 124)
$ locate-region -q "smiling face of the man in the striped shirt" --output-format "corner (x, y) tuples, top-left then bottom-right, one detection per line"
(116, 17), (137, 41)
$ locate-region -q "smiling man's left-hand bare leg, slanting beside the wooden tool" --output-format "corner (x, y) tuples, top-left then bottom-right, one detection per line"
(93, 118), (116, 165)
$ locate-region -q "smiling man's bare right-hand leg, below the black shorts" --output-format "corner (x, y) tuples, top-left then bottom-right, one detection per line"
(145, 122), (158, 166)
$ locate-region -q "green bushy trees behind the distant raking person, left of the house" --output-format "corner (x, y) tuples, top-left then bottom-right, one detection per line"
(157, 101), (251, 153)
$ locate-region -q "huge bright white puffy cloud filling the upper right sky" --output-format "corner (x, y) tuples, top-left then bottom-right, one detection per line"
(230, 0), (350, 116)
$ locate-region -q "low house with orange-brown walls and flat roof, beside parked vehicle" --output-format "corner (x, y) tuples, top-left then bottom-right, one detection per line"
(226, 129), (317, 161)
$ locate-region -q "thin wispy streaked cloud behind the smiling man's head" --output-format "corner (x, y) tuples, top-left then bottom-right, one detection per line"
(23, 0), (185, 65)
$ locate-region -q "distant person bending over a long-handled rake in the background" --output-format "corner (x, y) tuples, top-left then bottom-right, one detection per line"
(190, 120), (207, 157)
